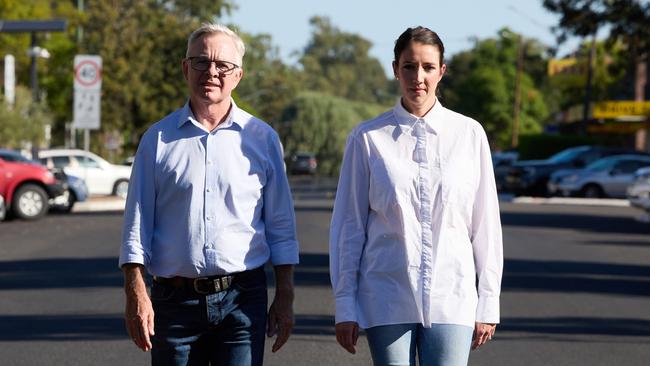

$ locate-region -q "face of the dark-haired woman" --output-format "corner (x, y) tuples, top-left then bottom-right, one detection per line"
(393, 42), (446, 117)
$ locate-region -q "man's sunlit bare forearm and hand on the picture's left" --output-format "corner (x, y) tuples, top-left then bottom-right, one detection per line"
(122, 263), (154, 351)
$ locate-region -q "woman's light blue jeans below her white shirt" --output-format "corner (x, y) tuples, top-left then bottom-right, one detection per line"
(366, 324), (474, 366)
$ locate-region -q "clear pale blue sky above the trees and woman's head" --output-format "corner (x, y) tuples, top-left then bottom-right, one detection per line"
(221, 0), (579, 75)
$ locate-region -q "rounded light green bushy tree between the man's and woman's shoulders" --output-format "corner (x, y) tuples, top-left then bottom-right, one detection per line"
(278, 92), (386, 176)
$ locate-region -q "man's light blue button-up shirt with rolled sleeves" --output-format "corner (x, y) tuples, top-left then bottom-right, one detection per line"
(119, 102), (298, 277)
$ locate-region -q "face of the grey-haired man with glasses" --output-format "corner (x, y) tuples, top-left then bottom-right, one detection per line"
(183, 33), (244, 104)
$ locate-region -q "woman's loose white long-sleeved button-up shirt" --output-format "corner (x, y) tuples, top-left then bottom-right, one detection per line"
(330, 101), (503, 328)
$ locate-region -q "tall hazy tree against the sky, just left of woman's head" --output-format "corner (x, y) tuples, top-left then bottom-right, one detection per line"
(300, 17), (395, 104)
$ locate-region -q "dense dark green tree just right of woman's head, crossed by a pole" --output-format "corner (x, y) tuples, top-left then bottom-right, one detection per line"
(441, 29), (548, 149)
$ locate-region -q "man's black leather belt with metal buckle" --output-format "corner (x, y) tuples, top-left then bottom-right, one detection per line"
(153, 267), (264, 295)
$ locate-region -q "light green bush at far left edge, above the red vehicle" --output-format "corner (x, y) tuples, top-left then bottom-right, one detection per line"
(0, 86), (51, 148)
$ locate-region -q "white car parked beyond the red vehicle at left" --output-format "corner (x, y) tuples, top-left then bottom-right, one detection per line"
(38, 149), (131, 198)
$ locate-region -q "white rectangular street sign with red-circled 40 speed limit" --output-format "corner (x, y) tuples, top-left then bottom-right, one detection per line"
(73, 55), (102, 130)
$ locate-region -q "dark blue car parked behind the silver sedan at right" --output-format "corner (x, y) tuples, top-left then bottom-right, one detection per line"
(505, 146), (634, 196)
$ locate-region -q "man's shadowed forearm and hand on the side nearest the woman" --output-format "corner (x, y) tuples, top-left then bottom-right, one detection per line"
(266, 265), (295, 352)
